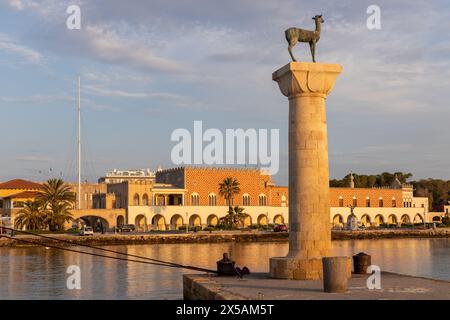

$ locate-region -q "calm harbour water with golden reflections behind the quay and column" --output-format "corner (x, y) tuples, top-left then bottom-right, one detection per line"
(0, 239), (450, 299)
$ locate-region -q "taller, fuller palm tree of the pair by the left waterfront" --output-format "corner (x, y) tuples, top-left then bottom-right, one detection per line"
(36, 179), (76, 231)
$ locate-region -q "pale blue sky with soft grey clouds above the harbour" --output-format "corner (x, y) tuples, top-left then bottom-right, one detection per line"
(0, 0), (450, 184)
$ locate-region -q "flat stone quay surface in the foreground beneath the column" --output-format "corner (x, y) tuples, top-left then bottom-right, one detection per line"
(183, 272), (450, 300)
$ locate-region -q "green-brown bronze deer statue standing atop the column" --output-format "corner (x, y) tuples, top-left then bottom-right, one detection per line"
(284, 15), (325, 62)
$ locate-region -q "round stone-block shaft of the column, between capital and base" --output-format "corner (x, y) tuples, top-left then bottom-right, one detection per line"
(288, 93), (331, 259)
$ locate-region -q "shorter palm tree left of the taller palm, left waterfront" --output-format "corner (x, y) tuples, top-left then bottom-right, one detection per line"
(14, 200), (45, 230)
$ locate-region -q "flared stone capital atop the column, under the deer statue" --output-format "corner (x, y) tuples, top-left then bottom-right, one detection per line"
(272, 62), (342, 98)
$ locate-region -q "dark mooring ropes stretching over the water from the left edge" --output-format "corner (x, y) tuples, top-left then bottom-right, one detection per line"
(0, 227), (218, 274)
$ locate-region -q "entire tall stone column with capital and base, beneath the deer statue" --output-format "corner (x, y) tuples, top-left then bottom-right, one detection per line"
(270, 62), (344, 280)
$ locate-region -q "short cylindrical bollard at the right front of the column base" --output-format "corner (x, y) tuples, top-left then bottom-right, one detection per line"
(322, 257), (348, 293)
